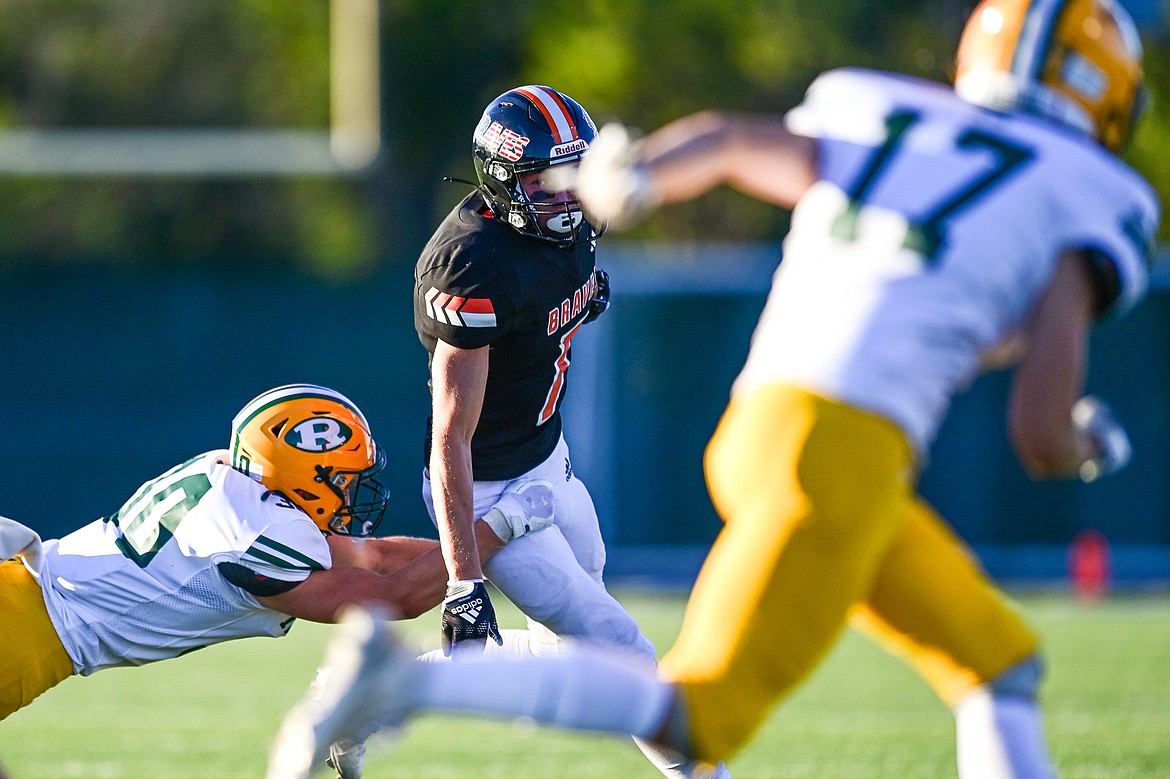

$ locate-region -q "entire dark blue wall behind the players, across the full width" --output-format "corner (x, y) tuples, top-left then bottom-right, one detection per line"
(0, 244), (1170, 578)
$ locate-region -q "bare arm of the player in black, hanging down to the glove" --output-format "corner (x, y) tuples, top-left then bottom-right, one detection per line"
(429, 340), (489, 580)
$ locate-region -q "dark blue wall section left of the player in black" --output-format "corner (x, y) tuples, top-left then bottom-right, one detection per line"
(0, 260), (429, 536)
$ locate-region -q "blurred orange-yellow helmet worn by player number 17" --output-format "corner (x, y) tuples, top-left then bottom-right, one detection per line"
(955, 0), (1143, 152)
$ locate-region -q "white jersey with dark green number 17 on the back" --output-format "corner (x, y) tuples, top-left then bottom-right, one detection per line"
(735, 70), (1158, 451)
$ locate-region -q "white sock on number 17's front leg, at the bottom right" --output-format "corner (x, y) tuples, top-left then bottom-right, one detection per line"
(955, 690), (1057, 779)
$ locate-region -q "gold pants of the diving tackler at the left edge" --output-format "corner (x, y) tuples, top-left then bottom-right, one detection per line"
(0, 560), (73, 719)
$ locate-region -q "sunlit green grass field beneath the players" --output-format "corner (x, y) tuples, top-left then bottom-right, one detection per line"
(0, 592), (1170, 779)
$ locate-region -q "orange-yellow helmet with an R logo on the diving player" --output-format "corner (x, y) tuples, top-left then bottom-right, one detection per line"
(230, 384), (390, 536)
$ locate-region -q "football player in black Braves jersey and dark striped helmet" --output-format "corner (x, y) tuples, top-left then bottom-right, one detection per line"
(414, 85), (720, 777)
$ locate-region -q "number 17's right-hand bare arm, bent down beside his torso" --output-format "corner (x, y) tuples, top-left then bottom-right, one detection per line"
(1009, 251), (1099, 478)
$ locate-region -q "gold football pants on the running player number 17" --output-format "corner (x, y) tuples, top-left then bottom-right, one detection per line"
(661, 385), (1037, 761)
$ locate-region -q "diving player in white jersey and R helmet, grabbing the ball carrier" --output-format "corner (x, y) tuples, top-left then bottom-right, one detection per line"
(0, 385), (552, 734)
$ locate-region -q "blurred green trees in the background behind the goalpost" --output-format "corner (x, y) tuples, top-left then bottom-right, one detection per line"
(0, 0), (1170, 280)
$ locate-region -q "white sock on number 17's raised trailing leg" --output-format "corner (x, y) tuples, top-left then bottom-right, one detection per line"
(419, 646), (674, 738)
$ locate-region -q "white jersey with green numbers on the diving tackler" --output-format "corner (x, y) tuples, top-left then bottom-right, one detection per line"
(36, 450), (331, 675)
